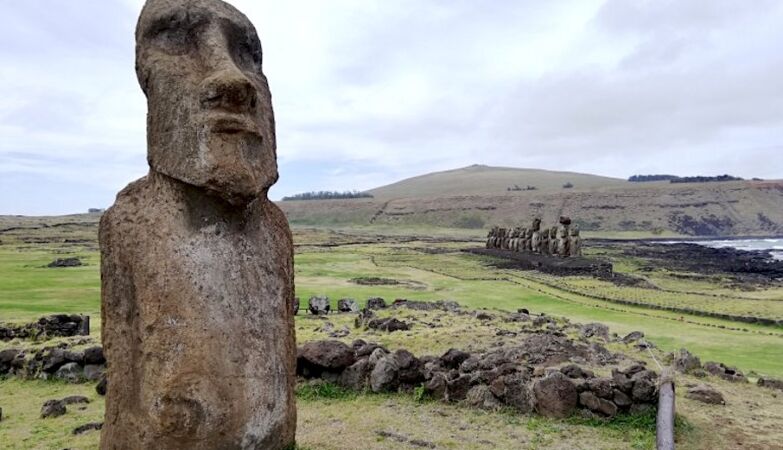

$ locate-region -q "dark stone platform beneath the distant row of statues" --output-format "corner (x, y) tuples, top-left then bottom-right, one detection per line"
(462, 248), (612, 277)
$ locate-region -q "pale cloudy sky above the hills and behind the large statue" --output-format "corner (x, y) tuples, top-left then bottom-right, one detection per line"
(0, 0), (783, 214)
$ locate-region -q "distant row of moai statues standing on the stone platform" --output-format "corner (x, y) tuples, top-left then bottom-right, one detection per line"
(487, 216), (582, 257)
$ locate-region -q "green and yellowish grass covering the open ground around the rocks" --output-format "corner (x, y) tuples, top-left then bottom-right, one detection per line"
(0, 223), (783, 449)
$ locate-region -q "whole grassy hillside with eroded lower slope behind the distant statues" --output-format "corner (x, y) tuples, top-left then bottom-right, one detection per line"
(278, 166), (783, 236)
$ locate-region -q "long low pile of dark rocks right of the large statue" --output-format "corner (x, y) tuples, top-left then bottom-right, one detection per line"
(297, 334), (658, 417)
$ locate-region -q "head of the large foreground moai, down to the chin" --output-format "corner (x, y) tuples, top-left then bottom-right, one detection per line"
(136, 0), (278, 203)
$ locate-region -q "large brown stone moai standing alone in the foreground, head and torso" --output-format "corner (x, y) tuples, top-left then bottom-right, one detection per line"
(99, 0), (296, 450)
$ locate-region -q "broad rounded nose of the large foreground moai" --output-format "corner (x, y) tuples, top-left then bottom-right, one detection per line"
(199, 69), (258, 114)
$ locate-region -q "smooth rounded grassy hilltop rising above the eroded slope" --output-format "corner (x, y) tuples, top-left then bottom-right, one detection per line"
(369, 164), (629, 200)
